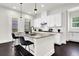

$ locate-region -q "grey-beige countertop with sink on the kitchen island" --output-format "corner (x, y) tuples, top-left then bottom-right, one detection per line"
(16, 32), (56, 39)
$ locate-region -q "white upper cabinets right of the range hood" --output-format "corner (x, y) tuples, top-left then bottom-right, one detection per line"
(47, 13), (61, 27)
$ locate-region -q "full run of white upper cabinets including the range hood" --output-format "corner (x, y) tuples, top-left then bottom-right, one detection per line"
(34, 13), (61, 27)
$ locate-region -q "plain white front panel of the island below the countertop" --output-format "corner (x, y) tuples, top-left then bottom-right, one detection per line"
(35, 36), (54, 56)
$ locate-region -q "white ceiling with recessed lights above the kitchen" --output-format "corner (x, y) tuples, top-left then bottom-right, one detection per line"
(0, 3), (78, 15)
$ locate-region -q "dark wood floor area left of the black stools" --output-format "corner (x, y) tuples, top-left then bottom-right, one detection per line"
(0, 42), (14, 56)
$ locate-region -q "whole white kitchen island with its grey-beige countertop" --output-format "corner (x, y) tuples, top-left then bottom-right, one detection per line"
(14, 32), (56, 56)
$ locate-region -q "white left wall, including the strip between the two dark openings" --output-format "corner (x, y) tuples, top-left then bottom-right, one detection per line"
(0, 7), (32, 43)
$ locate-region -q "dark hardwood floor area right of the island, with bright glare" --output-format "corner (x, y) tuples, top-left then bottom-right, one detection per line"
(52, 41), (79, 56)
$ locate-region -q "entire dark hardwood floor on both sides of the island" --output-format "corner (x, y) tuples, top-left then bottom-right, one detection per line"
(0, 41), (79, 56)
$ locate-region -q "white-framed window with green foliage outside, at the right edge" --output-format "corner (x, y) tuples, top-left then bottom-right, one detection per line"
(68, 8), (79, 32)
